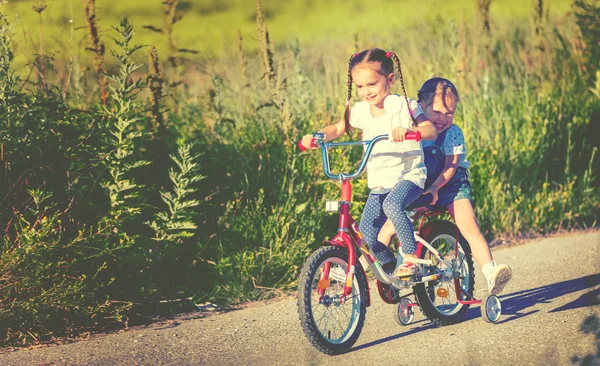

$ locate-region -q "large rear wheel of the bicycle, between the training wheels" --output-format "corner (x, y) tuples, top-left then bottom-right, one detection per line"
(414, 220), (475, 326)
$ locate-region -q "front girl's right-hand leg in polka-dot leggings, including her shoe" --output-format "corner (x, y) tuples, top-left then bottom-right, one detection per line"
(383, 180), (423, 277)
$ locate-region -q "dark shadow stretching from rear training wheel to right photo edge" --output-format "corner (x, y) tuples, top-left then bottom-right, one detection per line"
(500, 273), (600, 323)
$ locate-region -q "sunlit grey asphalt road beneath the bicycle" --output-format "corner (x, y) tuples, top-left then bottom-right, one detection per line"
(0, 232), (600, 366)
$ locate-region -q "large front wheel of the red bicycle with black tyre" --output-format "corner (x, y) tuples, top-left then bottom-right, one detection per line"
(298, 246), (368, 355)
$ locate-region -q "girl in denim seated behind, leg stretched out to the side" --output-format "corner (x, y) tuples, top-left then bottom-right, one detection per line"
(379, 78), (512, 295)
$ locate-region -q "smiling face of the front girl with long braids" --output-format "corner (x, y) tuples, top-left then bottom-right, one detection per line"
(352, 63), (394, 108)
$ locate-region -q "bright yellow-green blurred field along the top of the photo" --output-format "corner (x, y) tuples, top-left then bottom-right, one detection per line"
(0, 0), (570, 65)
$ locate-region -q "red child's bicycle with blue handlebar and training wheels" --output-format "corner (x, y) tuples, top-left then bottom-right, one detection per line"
(298, 132), (502, 355)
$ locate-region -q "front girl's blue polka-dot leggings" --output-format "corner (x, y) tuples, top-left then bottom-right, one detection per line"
(359, 180), (423, 254)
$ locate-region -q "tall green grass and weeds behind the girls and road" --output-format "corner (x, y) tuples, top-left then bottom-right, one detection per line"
(0, 0), (600, 345)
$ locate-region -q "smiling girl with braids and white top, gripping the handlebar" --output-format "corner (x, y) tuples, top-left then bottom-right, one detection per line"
(301, 48), (437, 277)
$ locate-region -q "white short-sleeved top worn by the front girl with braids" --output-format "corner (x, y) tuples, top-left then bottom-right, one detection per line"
(350, 97), (427, 194)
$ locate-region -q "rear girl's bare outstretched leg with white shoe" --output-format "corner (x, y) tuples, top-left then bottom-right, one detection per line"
(448, 199), (512, 295)
